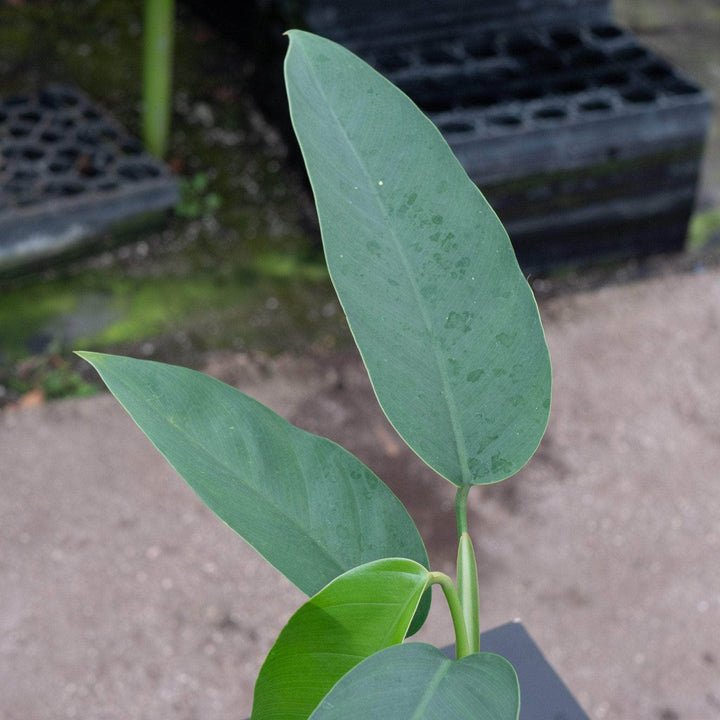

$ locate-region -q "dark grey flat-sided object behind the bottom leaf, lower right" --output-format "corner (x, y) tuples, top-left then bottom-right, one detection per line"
(245, 622), (589, 720)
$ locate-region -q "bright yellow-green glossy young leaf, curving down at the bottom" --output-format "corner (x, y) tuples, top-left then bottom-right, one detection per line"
(252, 559), (430, 720)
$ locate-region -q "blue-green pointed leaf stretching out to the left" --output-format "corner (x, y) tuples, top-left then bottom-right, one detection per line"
(79, 352), (428, 595)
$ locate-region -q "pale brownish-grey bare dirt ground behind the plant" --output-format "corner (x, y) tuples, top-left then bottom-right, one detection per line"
(0, 269), (720, 720)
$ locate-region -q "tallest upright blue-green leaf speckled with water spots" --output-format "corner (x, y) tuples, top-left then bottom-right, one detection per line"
(285, 30), (551, 485)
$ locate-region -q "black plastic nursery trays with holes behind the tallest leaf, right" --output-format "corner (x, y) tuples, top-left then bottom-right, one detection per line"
(306, 0), (711, 269)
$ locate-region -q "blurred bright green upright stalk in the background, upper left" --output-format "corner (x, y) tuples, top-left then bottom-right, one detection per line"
(143, 0), (175, 158)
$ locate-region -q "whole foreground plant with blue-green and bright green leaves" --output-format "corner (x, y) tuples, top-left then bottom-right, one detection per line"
(80, 30), (551, 720)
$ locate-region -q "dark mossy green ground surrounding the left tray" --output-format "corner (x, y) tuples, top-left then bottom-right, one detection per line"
(0, 0), (348, 399)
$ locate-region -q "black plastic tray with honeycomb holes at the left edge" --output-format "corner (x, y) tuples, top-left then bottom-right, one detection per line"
(0, 86), (178, 274)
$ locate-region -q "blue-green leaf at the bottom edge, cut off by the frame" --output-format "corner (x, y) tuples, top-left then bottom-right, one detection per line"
(310, 643), (520, 720)
